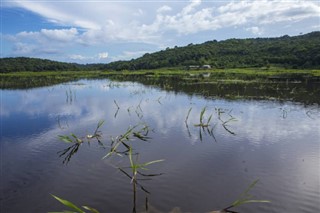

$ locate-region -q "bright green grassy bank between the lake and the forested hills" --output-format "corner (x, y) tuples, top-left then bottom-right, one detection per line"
(0, 67), (320, 89)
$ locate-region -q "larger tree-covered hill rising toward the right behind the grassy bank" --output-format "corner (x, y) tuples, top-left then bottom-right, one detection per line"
(104, 31), (320, 70)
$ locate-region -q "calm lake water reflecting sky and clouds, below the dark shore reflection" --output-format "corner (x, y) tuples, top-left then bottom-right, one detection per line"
(0, 80), (320, 213)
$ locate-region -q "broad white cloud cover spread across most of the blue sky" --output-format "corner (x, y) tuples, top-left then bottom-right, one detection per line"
(3, 0), (320, 60)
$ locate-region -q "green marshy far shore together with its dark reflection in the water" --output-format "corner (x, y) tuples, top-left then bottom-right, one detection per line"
(0, 67), (320, 104)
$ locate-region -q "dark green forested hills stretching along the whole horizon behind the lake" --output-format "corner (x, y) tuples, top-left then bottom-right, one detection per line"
(0, 31), (320, 73)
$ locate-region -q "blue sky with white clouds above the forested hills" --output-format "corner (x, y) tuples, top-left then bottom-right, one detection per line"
(0, 0), (320, 64)
